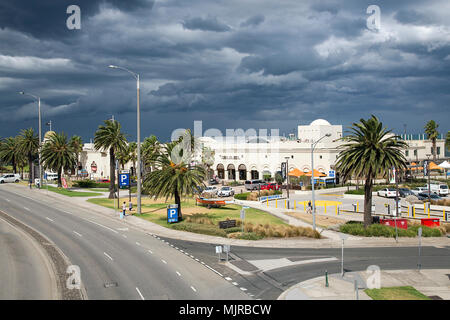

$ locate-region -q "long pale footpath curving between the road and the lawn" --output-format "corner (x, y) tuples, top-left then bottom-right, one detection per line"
(8, 184), (450, 248)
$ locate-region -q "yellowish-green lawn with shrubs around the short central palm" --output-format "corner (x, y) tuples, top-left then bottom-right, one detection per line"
(87, 196), (320, 240)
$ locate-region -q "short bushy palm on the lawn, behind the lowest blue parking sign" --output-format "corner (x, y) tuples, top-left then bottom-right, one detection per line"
(143, 144), (206, 220)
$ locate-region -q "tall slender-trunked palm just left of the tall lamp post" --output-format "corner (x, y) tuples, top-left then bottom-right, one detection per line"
(94, 120), (127, 199)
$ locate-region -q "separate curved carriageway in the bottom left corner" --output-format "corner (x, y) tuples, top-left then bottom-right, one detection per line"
(0, 218), (57, 300)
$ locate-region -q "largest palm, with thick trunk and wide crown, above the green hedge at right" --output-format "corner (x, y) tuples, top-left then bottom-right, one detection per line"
(336, 115), (408, 227)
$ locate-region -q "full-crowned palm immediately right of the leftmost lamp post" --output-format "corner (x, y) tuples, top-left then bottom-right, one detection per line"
(41, 133), (77, 188)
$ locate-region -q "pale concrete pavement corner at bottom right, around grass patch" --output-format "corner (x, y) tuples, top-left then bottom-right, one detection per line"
(278, 269), (450, 300)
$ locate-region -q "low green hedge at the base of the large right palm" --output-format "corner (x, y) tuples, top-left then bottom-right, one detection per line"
(339, 221), (443, 238)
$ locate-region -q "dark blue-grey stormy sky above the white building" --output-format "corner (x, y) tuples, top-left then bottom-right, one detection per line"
(0, 0), (450, 142)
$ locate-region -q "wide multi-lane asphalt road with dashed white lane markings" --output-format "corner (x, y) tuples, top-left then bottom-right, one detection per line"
(0, 185), (250, 300)
